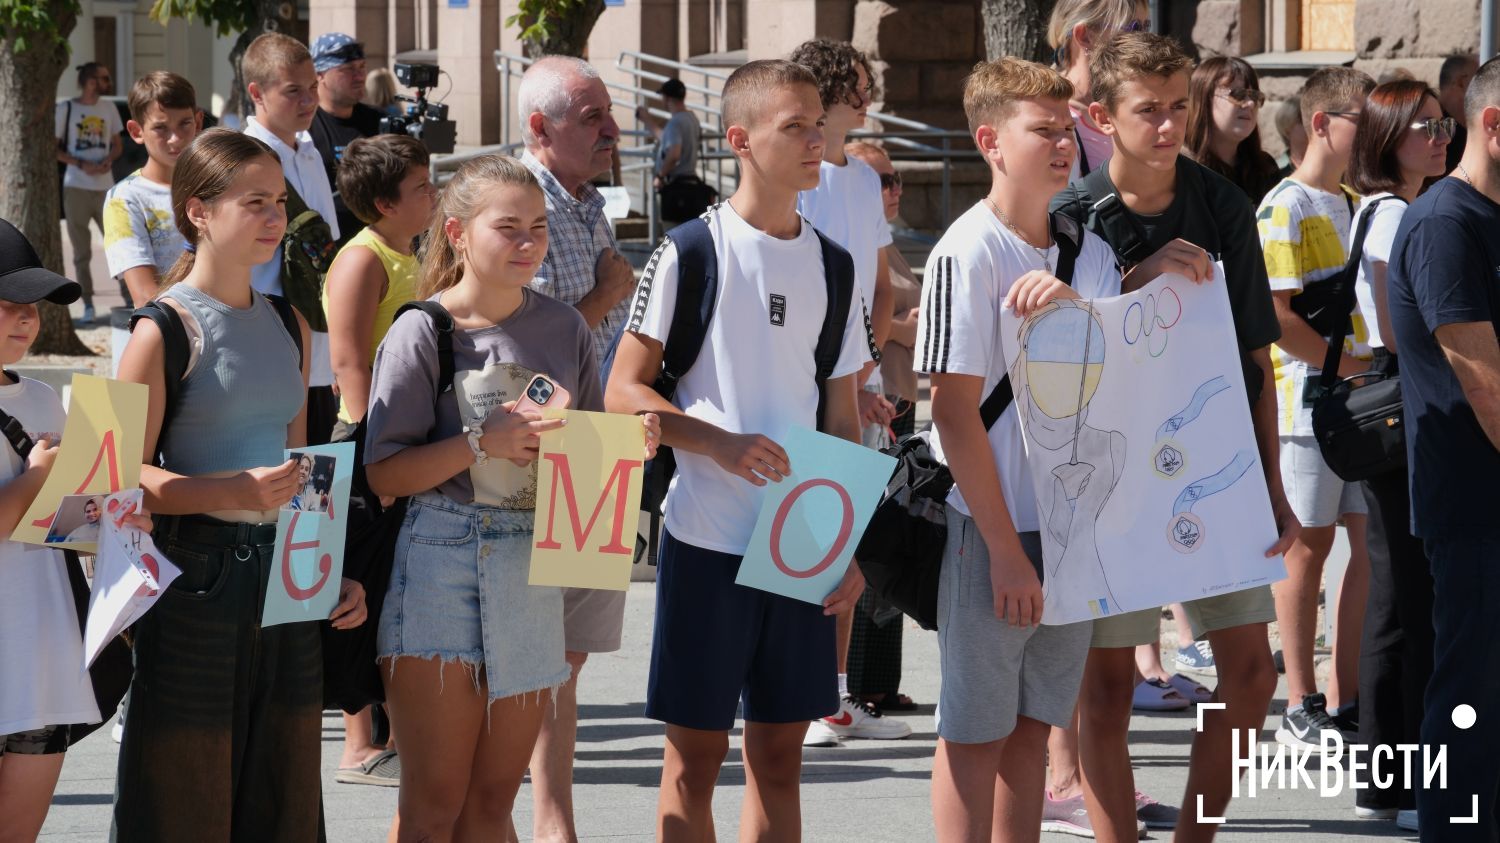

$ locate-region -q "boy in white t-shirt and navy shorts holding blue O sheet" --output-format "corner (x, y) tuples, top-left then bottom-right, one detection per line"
(605, 60), (870, 840)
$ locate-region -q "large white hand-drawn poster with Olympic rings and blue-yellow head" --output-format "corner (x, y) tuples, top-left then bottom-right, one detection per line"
(1001, 267), (1286, 624)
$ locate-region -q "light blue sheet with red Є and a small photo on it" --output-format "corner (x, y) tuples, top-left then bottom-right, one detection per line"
(261, 443), (354, 627)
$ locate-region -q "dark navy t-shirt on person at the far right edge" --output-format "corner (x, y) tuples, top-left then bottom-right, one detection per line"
(1389, 179), (1500, 539)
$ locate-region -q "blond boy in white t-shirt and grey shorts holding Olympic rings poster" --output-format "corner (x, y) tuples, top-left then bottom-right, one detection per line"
(917, 59), (1121, 840)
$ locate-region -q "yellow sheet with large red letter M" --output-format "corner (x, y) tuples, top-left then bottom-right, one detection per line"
(528, 410), (647, 591)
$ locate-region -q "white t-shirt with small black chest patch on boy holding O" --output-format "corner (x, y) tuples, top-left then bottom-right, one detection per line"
(627, 203), (870, 555)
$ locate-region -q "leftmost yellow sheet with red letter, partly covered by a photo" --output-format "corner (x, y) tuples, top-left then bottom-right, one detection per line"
(12, 375), (149, 554)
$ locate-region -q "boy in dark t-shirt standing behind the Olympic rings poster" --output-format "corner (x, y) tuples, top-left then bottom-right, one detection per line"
(1053, 33), (1298, 842)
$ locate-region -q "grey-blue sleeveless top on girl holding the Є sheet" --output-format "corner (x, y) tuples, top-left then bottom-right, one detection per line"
(162, 284), (308, 477)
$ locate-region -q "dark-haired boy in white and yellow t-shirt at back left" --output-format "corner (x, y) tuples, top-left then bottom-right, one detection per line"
(104, 71), (203, 306)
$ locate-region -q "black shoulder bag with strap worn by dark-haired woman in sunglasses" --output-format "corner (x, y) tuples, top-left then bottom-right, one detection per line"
(1314, 197), (1407, 483)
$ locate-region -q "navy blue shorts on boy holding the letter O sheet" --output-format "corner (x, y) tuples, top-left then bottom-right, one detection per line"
(647, 530), (839, 732)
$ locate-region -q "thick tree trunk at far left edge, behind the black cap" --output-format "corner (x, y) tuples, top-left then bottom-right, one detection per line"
(0, 0), (93, 354)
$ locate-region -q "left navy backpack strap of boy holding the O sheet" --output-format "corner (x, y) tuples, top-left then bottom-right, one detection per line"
(651, 218), (719, 401)
